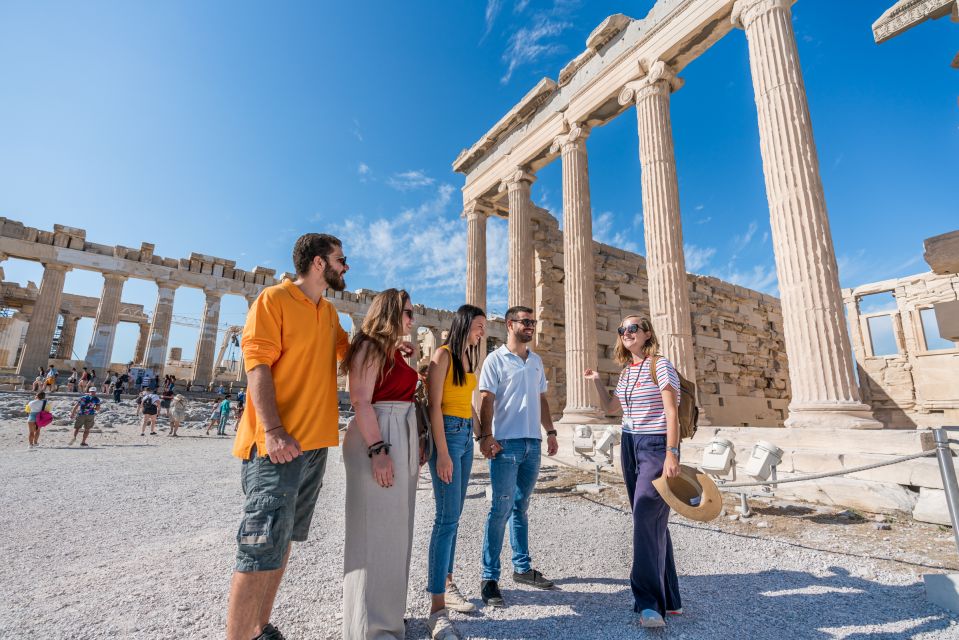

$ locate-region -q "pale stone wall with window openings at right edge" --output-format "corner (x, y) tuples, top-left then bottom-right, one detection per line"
(843, 273), (959, 429)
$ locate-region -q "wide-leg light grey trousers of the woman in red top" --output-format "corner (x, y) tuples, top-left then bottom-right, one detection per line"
(343, 402), (419, 640)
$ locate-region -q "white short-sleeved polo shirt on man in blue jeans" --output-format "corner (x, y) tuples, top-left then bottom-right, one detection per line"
(479, 344), (546, 440)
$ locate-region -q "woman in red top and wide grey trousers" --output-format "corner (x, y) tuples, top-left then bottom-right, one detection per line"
(343, 289), (420, 640)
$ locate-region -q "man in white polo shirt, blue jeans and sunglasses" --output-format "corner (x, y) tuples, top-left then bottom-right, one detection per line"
(477, 307), (559, 607)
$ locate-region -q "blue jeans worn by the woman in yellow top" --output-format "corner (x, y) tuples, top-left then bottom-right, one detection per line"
(426, 416), (473, 594)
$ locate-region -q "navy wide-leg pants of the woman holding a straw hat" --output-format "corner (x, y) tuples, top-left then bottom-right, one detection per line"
(620, 431), (683, 617)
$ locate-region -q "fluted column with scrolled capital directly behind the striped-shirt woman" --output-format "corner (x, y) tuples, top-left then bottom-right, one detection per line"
(619, 60), (696, 381)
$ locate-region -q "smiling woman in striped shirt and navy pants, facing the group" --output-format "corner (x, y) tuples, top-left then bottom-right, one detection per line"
(584, 316), (682, 627)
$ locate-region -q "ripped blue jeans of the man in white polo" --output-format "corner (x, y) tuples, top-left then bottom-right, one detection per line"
(482, 438), (542, 580)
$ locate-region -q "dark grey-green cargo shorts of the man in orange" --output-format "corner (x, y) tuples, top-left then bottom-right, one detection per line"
(236, 446), (328, 573)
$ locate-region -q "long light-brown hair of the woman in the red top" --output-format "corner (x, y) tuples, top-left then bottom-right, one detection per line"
(340, 289), (410, 380)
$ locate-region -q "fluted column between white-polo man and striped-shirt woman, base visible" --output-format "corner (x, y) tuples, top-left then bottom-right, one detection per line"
(550, 124), (603, 423)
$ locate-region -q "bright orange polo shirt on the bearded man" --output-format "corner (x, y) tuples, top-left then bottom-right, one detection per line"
(233, 280), (349, 460)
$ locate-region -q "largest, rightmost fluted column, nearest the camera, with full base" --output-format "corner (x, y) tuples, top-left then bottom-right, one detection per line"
(732, 0), (881, 429)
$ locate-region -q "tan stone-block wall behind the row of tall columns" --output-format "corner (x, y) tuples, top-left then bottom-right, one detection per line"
(533, 209), (789, 427)
